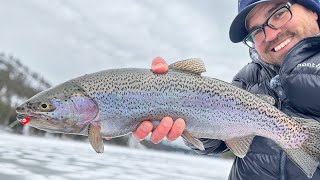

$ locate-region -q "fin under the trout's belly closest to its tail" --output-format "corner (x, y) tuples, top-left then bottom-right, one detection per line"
(225, 136), (254, 158)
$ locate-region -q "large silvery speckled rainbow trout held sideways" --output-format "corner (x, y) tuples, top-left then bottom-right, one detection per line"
(17, 59), (320, 177)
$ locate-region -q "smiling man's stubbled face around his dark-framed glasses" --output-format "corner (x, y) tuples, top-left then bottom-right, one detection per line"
(246, 1), (320, 65)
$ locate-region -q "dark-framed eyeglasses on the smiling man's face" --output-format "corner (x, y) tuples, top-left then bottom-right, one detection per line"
(243, 2), (293, 48)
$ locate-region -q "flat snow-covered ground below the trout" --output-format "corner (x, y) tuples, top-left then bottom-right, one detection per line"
(0, 132), (232, 180)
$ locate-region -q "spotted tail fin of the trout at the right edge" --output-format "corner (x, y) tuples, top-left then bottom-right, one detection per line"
(285, 118), (320, 178)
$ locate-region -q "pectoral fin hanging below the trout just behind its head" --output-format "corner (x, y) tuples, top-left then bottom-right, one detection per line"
(88, 124), (104, 153)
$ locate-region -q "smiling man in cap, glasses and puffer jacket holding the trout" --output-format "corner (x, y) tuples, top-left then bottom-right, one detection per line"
(134, 0), (320, 180)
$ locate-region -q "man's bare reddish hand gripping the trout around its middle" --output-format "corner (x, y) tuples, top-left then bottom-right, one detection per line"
(133, 57), (186, 144)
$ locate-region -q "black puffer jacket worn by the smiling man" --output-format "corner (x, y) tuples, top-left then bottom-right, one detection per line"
(189, 35), (320, 180)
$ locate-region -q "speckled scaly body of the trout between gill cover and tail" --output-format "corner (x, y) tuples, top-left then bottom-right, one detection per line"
(69, 69), (304, 146)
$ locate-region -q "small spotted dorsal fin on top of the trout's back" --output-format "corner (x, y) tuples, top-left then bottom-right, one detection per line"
(169, 58), (206, 75)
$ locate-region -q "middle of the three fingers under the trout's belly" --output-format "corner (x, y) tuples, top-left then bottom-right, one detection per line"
(150, 117), (173, 144)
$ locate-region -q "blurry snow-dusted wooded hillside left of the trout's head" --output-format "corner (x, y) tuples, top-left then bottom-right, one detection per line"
(0, 53), (51, 132)
